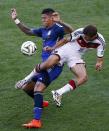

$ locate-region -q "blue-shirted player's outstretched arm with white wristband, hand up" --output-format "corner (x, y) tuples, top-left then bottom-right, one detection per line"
(11, 9), (34, 35)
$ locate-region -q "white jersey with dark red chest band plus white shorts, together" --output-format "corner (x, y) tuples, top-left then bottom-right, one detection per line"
(53, 28), (105, 68)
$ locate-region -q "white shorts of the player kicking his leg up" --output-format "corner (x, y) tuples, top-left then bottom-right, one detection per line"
(52, 44), (85, 68)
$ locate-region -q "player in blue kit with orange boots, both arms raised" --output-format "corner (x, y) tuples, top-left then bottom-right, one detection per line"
(11, 8), (72, 128)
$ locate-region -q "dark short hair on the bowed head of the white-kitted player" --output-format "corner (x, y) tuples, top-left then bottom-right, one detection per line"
(83, 25), (97, 37)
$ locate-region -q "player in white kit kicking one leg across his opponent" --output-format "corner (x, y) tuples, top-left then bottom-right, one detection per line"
(36, 25), (105, 106)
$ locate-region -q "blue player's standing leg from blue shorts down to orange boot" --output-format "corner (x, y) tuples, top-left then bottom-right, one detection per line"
(23, 65), (63, 128)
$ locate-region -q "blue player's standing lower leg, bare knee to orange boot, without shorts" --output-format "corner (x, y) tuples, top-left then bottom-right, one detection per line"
(23, 81), (46, 128)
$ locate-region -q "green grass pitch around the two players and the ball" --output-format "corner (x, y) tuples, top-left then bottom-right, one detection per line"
(0, 0), (109, 131)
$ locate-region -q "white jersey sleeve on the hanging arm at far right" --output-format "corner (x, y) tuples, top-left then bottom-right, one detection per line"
(97, 37), (106, 57)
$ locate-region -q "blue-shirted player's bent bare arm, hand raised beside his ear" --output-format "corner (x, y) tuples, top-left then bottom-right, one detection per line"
(53, 12), (74, 34)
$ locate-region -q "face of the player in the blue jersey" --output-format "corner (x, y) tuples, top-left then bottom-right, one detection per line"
(41, 14), (53, 27)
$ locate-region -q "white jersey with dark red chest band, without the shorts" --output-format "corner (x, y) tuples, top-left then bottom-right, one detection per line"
(70, 28), (105, 57)
